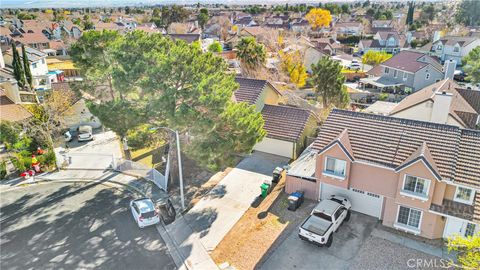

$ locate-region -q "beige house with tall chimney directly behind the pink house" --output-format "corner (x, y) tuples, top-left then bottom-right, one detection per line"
(390, 79), (480, 129)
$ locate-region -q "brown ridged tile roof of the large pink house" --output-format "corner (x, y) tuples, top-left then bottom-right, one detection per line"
(314, 109), (480, 188)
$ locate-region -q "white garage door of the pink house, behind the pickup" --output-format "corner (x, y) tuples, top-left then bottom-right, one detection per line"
(320, 183), (383, 218)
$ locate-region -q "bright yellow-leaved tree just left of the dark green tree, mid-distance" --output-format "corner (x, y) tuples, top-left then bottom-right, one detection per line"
(278, 51), (307, 87)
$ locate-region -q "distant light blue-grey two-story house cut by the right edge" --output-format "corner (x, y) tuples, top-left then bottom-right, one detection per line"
(430, 37), (480, 65)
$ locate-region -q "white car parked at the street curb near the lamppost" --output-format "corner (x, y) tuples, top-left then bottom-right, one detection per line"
(130, 198), (160, 228)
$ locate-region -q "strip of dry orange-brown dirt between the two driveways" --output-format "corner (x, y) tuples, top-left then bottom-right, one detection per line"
(211, 177), (315, 269)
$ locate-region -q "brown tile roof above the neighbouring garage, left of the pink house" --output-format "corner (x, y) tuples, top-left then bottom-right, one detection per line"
(262, 104), (312, 142)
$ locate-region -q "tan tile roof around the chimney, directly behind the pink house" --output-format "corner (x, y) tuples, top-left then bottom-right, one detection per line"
(390, 79), (480, 128)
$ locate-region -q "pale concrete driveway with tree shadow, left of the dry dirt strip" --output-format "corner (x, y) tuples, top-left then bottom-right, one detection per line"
(185, 152), (288, 251)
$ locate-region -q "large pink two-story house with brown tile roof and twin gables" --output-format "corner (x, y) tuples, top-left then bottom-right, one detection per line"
(285, 109), (480, 239)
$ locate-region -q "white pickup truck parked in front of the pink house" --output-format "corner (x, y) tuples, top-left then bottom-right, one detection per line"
(298, 195), (352, 247)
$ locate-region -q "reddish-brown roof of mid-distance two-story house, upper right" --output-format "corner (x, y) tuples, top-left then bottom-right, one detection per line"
(381, 51), (441, 73)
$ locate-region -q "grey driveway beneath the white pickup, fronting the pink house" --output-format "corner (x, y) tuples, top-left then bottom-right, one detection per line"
(258, 212), (445, 270)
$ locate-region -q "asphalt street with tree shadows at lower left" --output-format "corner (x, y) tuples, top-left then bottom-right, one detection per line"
(0, 183), (176, 270)
